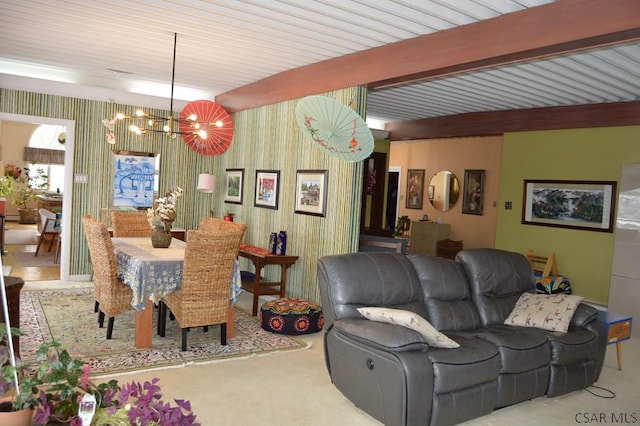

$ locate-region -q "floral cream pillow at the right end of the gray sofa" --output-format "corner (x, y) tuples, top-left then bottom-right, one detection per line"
(504, 293), (582, 333)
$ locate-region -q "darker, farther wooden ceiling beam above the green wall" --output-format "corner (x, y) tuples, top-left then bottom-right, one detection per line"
(385, 101), (640, 141)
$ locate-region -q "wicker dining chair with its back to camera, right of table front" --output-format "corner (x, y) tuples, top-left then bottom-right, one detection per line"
(158, 223), (246, 351)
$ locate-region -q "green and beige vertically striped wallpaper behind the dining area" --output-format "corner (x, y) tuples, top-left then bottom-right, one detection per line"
(0, 88), (366, 302)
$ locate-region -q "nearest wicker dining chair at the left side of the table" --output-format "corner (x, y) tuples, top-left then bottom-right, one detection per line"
(82, 216), (133, 339)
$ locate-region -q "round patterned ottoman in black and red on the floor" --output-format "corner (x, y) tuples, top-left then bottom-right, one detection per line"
(258, 297), (324, 334)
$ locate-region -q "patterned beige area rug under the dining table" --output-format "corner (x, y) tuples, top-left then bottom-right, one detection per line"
(20, 288), (307, 375)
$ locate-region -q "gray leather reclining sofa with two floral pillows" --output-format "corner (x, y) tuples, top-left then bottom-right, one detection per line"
(318, 249), (606, 426)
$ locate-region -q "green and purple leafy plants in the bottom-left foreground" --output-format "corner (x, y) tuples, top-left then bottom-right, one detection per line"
(0, 324), (199, 426)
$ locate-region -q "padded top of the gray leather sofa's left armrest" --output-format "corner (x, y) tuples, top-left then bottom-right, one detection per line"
(333, 319), (429, 352)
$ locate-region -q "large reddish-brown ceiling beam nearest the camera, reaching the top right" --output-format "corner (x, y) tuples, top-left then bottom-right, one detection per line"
(215, 0), (640, 111)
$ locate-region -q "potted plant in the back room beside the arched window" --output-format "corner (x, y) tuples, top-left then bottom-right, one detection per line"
(4, 163), (49, 223)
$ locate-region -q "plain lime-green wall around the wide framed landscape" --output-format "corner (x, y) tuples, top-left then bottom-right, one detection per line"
(496, 126), (640, 304)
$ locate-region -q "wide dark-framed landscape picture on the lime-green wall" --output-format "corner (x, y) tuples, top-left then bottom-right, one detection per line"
(522, 180), (616, 232)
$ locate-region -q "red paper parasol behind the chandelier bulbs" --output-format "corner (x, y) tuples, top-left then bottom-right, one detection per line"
(178, 100), (233, 155)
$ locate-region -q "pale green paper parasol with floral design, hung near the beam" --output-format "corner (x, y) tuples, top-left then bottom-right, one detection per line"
(296, 96), (373, 162)
